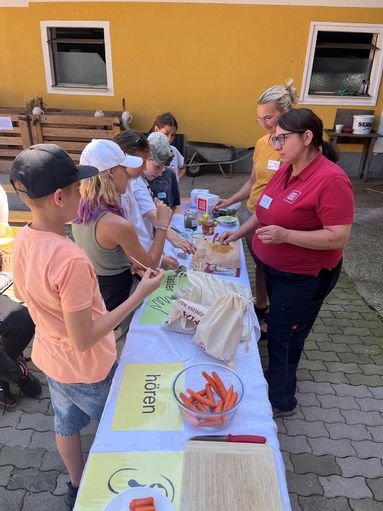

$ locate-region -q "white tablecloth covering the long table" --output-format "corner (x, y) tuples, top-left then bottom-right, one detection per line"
(87, 215), (291, 511)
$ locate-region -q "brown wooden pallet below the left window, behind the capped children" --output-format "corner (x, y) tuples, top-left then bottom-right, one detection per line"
(30, 113), (120, 163)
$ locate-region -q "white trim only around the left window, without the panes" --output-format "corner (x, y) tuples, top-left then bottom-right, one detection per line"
(40, 20), (114, 96)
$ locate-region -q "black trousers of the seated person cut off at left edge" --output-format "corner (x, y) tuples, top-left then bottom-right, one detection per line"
(0, 295), (35, 382)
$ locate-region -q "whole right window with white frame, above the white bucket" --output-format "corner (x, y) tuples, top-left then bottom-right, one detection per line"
(300, 22), (383, 106)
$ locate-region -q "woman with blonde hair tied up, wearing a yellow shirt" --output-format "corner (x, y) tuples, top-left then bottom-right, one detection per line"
(215, 78), (298, 320)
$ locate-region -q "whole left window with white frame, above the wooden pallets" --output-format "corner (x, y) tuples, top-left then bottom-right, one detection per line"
(41, 21), (113, 96)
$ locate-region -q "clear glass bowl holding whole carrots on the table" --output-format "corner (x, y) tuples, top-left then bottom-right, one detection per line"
(173, 363), (244, 432)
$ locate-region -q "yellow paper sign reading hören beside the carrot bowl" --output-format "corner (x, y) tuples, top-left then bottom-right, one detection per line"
(111, 363), (184, 431)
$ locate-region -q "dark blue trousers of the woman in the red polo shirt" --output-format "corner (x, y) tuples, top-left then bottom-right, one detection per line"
(265, 261), (342, 411)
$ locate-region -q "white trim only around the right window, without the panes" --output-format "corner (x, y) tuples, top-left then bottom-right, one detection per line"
(299, 21), (383, 106)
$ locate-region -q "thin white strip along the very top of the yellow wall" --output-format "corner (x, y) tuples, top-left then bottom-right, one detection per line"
(0, 0), (383, 9)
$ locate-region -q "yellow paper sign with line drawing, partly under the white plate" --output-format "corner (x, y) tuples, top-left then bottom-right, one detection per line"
(75, 451), (183, 511)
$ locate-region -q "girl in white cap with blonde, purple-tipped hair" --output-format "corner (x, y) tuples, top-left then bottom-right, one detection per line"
(72, 140), (173, 310)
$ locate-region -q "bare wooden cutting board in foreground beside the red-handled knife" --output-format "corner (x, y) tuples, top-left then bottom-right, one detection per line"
(181, 440), (283, 511)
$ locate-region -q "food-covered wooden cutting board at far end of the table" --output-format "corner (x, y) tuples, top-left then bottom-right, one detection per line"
(191, 237), (241, 276)
